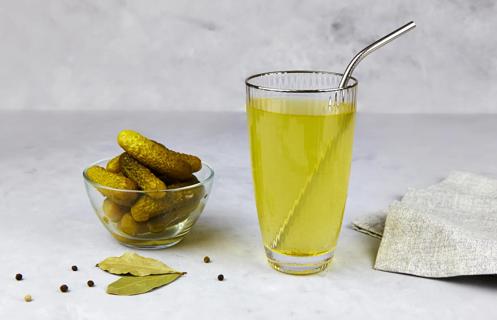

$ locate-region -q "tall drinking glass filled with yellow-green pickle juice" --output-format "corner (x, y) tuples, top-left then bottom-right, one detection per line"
(245, 71), (357, 274)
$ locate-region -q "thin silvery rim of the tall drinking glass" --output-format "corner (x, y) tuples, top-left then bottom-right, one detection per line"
(245, 70), (358, 93)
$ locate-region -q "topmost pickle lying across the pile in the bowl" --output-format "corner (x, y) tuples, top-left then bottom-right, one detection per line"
(117, 130), (192, 180)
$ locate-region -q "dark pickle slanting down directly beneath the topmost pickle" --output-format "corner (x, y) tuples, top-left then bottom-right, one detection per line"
(119, 153), (166, 199)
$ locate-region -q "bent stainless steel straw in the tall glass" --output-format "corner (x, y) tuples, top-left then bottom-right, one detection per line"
(271, 21), (416, 249)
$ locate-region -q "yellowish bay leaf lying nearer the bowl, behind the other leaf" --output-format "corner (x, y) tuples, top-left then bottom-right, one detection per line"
(97, 252), (179, 277)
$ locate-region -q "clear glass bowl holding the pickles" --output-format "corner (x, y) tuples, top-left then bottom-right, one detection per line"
(83, 159), (214, 249)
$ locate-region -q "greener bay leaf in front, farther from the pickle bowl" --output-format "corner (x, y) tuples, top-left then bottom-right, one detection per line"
(107, 272), (184, 296)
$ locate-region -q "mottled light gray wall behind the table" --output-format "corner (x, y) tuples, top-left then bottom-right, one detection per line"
(0, 0), (497, 113)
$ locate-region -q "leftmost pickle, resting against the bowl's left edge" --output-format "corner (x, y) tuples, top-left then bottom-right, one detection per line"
(86, 166), (138, 206)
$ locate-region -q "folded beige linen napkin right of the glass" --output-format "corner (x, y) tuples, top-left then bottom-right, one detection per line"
(353, 171), (497, 278)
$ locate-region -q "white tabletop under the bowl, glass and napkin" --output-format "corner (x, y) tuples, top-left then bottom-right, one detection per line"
(0, 112), (497, 320)
